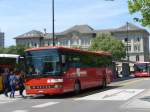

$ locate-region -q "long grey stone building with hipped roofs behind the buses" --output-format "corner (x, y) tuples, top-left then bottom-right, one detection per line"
(15, 23), (149, 61)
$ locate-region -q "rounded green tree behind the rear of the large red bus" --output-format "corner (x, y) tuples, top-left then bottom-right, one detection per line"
(89, 33), (126, 60)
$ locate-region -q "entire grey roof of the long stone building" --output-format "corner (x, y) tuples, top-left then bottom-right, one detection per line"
(15, 23), (149, 39)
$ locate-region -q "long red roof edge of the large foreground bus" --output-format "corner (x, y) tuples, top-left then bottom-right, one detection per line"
(25, 46), (112, 56)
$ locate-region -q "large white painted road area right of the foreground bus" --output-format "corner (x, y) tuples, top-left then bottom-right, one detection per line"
(74, 89), (144, 101)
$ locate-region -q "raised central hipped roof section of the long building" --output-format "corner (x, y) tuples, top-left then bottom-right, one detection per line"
(60, 25), (94, 35)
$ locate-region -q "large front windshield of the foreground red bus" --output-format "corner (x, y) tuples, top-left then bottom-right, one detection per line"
(26, 49), (60, 76)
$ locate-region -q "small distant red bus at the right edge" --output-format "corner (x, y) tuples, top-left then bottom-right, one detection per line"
(134, 62), (150, 77)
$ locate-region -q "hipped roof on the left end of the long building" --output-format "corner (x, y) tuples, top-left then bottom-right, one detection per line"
(15, 30), (43, 39)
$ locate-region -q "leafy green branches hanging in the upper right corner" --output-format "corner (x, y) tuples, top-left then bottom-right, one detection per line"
(128, 0), (150, 27)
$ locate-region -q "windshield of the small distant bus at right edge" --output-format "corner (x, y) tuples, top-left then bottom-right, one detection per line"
(135, 63), (148, 72)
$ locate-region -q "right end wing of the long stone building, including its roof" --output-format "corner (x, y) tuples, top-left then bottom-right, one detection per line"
(112, 24), (149, 61)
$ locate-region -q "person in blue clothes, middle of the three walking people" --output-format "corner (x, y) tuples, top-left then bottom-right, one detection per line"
(9, 71), (17, 98)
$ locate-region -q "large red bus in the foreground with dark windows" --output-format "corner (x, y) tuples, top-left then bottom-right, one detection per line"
(25, 47), (112, 94)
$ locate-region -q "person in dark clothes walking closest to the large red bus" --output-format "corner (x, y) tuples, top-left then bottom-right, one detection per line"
(17, 72), (25, 97)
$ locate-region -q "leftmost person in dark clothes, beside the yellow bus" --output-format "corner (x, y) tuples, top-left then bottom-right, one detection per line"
(2, 69), (10, 97)
